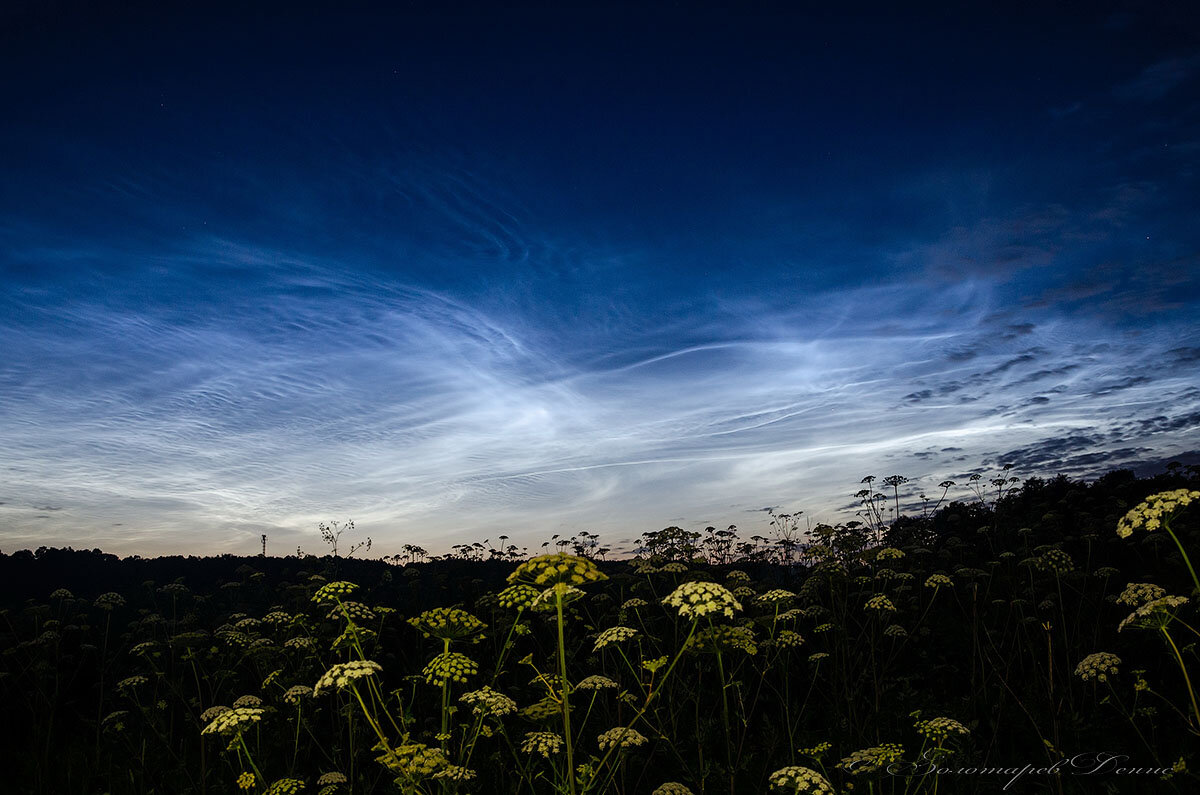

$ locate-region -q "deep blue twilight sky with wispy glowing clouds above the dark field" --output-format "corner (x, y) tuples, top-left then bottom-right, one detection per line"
(0, 0), (1200, 555)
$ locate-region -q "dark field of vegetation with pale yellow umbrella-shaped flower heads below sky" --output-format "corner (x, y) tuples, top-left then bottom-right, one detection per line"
(0, 466), (1200, 795)
